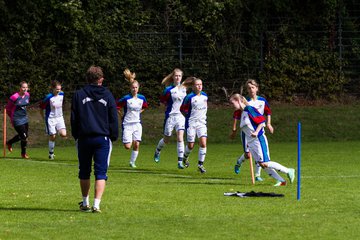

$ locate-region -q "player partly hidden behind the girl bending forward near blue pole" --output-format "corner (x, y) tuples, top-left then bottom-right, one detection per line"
(231, 79), (274, 181)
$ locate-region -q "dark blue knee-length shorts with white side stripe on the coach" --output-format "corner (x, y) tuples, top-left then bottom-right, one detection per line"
(77, 136), (112, 180)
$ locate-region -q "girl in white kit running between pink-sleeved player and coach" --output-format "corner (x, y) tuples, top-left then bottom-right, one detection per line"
(40, 80), (66, 159)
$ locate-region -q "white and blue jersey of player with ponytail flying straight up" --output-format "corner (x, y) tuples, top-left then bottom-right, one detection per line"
(117, 94), (148, 125)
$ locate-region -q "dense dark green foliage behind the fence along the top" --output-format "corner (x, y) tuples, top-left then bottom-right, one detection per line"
(0, 0), (359, 102)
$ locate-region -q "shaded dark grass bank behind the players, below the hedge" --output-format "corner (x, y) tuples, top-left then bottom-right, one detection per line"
(0, 102), (360, 147)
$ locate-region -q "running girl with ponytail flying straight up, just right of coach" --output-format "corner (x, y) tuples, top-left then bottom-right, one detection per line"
(117, 69), (148, 168)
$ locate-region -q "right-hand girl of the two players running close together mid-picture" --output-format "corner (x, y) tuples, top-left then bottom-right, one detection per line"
(180, 77), (208, 173)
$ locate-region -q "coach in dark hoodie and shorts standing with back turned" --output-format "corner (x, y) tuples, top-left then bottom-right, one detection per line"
(71, 66), (119, 213)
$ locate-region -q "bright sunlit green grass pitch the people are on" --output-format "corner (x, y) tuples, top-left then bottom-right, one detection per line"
(0, 141), (360, 239)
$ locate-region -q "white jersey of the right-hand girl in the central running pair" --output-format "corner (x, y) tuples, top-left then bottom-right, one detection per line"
(180, 92), (208, 127)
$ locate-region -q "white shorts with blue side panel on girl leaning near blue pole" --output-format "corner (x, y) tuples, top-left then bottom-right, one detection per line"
(247, 134), (270, 162)
